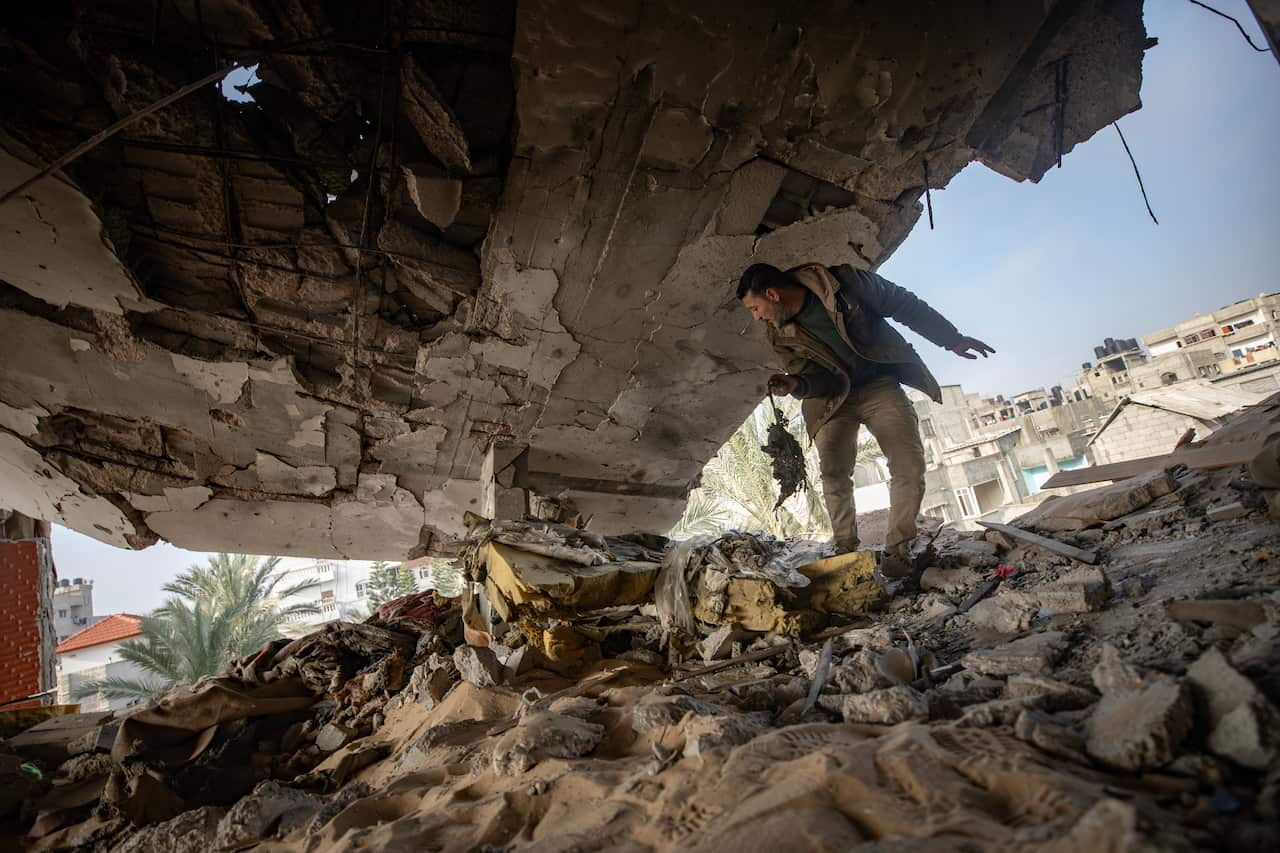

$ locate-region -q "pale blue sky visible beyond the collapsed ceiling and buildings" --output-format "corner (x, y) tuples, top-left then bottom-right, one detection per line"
(54, 0), (1280, 613)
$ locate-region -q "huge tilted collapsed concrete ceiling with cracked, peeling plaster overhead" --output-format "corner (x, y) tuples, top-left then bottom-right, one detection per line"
(0, 0), (1149, 558)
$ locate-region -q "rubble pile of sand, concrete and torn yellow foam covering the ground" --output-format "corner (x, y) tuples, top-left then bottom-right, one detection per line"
(0, 446), (1280, 853)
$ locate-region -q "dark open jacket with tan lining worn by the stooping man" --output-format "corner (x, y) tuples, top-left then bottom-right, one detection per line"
(768, 264), (960, 437)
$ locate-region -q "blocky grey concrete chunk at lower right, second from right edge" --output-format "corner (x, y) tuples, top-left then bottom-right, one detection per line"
(1085, 675), (1194, 770)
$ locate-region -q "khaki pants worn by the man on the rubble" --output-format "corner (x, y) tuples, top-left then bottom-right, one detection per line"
(813, 379), (924, 551)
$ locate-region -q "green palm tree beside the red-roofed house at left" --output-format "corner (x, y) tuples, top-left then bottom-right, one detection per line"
(74, 553), (315, 699)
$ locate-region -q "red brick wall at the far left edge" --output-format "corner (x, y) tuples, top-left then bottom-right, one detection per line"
(0, 538), (56, 708)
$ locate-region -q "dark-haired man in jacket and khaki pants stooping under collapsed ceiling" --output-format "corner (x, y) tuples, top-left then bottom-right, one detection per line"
(737, 264), (995, 576)
